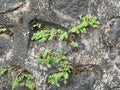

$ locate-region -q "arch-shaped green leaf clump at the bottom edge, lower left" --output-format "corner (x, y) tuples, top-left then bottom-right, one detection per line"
(12, 73), (35, 90)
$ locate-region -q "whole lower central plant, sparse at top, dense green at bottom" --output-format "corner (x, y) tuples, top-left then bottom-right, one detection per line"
(37, 48), (72, 87)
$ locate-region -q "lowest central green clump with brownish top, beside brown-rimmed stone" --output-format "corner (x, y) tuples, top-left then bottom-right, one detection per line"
(48, 57), (73, 87)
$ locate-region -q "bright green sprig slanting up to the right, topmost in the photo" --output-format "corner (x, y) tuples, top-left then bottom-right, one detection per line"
(68, 15), (99, 34)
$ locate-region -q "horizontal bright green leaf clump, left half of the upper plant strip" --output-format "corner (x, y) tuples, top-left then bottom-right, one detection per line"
(32, 29), (68, 42)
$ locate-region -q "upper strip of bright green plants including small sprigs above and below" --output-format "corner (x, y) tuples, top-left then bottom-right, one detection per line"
(32, 15), (99, 48)
